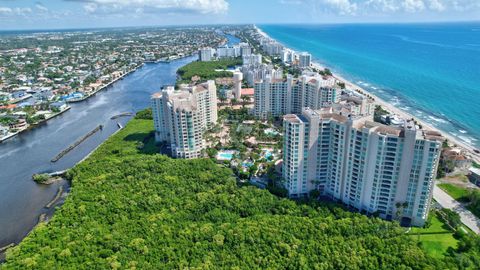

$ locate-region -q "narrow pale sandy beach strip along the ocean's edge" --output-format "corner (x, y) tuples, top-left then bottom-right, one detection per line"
(254, 25), (480, 163)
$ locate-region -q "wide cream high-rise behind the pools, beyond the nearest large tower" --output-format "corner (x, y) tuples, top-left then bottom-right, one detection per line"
(254, 72), (341, 119)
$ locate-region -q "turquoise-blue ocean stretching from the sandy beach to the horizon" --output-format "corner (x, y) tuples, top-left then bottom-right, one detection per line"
(258, 22), (480, 148)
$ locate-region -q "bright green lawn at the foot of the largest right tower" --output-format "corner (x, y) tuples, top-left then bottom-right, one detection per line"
(408, 213), (458, 259)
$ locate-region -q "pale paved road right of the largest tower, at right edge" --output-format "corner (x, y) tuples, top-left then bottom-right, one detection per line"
(433, 185), (480, 234)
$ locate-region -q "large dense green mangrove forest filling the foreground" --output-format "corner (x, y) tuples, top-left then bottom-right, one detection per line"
(2, 119), (480, 269)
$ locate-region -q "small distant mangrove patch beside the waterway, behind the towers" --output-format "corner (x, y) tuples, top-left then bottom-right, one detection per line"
(177, 58), (242, 83)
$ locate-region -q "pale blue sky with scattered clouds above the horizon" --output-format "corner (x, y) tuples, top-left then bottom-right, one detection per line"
(0, 0), (480, 30)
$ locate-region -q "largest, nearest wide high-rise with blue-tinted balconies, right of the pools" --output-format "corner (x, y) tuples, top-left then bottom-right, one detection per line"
(283, 108), (444, 226)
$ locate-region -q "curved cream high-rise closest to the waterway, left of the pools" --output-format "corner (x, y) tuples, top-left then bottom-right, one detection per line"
(152, 81), (217, 158)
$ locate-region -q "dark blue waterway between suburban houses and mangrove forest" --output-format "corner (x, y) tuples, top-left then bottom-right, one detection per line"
(0, 56), (196, 247)
